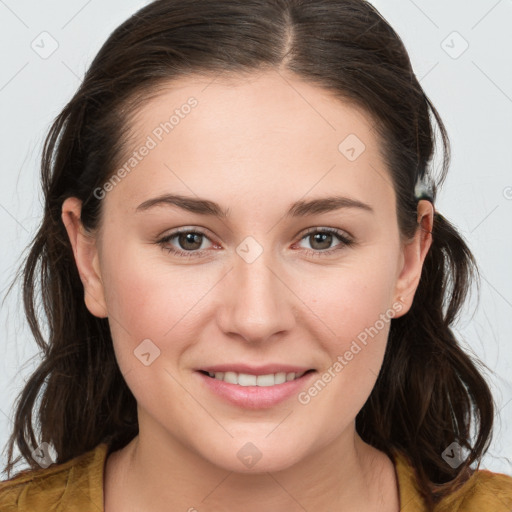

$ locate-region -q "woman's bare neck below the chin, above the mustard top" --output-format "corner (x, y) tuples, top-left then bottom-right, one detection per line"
(105, 418), (398, 512)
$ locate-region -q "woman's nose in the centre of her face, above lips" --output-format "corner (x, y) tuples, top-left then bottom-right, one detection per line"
(217, 244), (299, 343)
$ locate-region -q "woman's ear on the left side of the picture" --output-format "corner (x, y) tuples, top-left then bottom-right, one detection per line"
(62, 197), (108, 318)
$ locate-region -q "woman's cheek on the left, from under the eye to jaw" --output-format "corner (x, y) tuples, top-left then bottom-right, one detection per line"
(100, 253), (214, 424)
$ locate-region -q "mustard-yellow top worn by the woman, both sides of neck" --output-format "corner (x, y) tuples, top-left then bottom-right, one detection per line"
(0, 443), (512, 512)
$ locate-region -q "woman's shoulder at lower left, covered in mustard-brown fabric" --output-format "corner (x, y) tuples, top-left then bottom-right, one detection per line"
(0, 443), (108, 512)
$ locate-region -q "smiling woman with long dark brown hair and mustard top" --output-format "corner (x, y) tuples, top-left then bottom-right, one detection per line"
(0, 0), (512, 512)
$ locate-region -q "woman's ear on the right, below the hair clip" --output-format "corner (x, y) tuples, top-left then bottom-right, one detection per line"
(395, 200), (434, 318)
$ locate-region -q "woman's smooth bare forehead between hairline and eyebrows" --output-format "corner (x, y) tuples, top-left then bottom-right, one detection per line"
(103, 71), (392, 218)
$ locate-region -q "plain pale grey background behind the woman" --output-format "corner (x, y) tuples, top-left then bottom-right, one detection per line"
(0, 0), (512, 475)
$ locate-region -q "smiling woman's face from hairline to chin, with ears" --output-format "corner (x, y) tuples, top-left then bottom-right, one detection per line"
(64, 72), (431, 471)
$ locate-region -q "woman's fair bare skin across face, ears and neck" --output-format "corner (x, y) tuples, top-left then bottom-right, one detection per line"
(62, 72), (433, 512)
